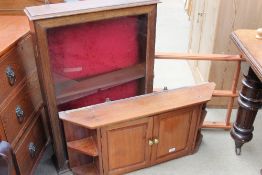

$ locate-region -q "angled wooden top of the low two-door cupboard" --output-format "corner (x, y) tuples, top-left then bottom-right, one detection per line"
(59, 83), (215, 129)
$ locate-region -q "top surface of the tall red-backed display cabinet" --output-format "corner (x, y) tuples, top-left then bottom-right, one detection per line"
(24, 0), (159, 20)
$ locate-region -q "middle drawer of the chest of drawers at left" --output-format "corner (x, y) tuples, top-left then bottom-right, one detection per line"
(0, 72), (43, 145)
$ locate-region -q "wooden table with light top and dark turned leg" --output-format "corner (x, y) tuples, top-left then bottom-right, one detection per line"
(230, 30), (262, 155)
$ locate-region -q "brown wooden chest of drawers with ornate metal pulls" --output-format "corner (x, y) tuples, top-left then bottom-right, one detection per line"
(0, 16), (47, 175)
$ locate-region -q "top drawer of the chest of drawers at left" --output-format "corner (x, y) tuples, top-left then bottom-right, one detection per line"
(0, 34), (36, 101)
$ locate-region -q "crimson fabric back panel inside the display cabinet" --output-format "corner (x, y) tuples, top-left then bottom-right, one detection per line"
(47, 15), (147, 110)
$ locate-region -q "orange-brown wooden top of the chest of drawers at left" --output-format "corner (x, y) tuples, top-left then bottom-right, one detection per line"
(0, 16), (30, 56)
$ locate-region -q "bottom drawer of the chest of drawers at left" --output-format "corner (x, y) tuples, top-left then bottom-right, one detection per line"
(14, 115), (47, 175)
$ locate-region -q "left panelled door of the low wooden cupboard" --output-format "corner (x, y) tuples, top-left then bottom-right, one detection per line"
(102, 118), (153, 175)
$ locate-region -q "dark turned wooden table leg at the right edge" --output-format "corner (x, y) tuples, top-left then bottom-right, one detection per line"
(230, 68), (262, 155)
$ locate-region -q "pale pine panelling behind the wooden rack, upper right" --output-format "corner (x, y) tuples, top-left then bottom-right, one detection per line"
(189, 0), (262, 107)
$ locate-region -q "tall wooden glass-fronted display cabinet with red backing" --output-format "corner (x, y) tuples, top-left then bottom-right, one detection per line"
(25, 0), (158, 171)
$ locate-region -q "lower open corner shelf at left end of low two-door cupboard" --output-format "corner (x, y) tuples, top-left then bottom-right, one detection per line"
(72, 163), (99, 175)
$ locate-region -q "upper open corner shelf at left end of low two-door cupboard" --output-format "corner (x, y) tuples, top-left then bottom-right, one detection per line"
(67, 136), (98, 157)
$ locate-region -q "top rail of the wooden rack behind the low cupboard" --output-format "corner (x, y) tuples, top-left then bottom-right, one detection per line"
(155, 52), (245, 61)
